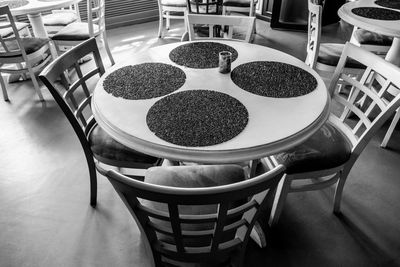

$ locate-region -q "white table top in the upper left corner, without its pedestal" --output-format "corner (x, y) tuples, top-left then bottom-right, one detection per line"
(10, 0), (82, 16)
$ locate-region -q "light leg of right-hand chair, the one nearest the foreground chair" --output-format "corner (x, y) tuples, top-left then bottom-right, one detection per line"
(269, 175), (292, 226)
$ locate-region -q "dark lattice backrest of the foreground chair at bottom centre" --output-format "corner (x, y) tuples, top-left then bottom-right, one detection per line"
(106, 165), (284, 266)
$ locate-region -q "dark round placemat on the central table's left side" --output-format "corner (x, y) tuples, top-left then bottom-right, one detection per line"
(103, 63), (186, 100)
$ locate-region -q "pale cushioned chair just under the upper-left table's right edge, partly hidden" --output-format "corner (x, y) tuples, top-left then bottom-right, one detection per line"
(42, 4), (81, 36)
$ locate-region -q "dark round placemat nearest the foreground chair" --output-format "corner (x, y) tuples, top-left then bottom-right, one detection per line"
(146, 90), (249, 147)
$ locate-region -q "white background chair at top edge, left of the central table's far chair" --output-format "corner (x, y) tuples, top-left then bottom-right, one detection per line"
(158, 0), (187, 38)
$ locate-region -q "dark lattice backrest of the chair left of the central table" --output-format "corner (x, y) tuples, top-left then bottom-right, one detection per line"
(39, 38), (104, 149)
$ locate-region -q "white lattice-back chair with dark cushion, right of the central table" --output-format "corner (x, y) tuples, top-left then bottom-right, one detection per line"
(264, 43), (400, 224)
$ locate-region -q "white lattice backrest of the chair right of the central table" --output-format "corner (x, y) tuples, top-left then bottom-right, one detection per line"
(329, 43), (400, 168)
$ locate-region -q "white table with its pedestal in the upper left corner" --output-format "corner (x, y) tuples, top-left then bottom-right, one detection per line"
(10, 0), (82, 37)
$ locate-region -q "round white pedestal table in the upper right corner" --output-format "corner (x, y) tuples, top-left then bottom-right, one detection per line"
(338, 0), (400, 66)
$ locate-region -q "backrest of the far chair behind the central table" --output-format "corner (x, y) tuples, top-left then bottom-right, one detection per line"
(186, 14), (255, 42)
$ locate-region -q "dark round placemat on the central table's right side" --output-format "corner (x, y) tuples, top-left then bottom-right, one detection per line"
(231, 61), (318, 98)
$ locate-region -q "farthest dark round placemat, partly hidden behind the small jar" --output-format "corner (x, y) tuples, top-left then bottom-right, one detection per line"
(169, 42), (238, 69)
